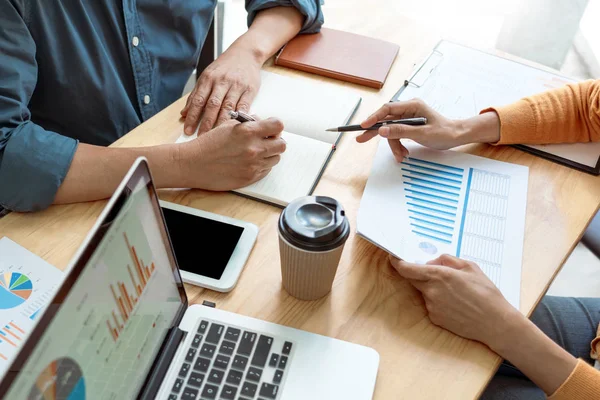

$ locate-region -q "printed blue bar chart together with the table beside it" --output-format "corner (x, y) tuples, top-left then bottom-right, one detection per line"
(402, 157), (511, 284)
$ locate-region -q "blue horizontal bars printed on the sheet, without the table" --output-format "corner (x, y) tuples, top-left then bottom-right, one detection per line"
(402, 157), (465, 244)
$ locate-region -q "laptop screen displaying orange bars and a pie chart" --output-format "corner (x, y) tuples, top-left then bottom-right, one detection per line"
(6, 163), (185, 400)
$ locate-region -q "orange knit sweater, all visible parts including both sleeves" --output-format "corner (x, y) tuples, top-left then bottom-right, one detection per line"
(482, 80), (600, 400)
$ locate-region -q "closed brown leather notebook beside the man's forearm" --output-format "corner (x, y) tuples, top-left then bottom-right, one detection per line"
(275, 28), (400, 89)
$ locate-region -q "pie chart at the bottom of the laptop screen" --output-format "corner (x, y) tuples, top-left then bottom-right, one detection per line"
(27, 357), (85, 400)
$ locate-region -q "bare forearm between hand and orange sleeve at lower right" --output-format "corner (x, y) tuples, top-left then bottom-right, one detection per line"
(488, 310), (577, 395)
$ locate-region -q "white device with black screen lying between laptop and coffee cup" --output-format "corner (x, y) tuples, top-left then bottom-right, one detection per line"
(160, 200), (258, 292)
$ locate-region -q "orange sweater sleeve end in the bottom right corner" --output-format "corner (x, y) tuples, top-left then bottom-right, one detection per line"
(548, 360), (600, 400)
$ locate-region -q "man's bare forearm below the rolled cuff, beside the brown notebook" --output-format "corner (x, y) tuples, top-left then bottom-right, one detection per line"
(228, 7), (304, 65)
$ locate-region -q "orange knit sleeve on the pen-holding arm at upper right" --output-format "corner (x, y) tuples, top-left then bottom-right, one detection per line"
(481, 80), (600, 144)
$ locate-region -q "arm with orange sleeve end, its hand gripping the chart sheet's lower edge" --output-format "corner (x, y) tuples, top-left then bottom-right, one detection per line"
(390, 255), (600, 400)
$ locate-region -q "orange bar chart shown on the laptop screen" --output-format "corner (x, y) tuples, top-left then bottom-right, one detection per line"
(106, 233), (154, 342)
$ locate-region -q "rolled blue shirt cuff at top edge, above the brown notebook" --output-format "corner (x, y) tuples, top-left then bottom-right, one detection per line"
(246, 0), (325, 33)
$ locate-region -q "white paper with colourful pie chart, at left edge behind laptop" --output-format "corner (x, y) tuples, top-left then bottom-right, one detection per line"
(0, 237), (64, 376)
